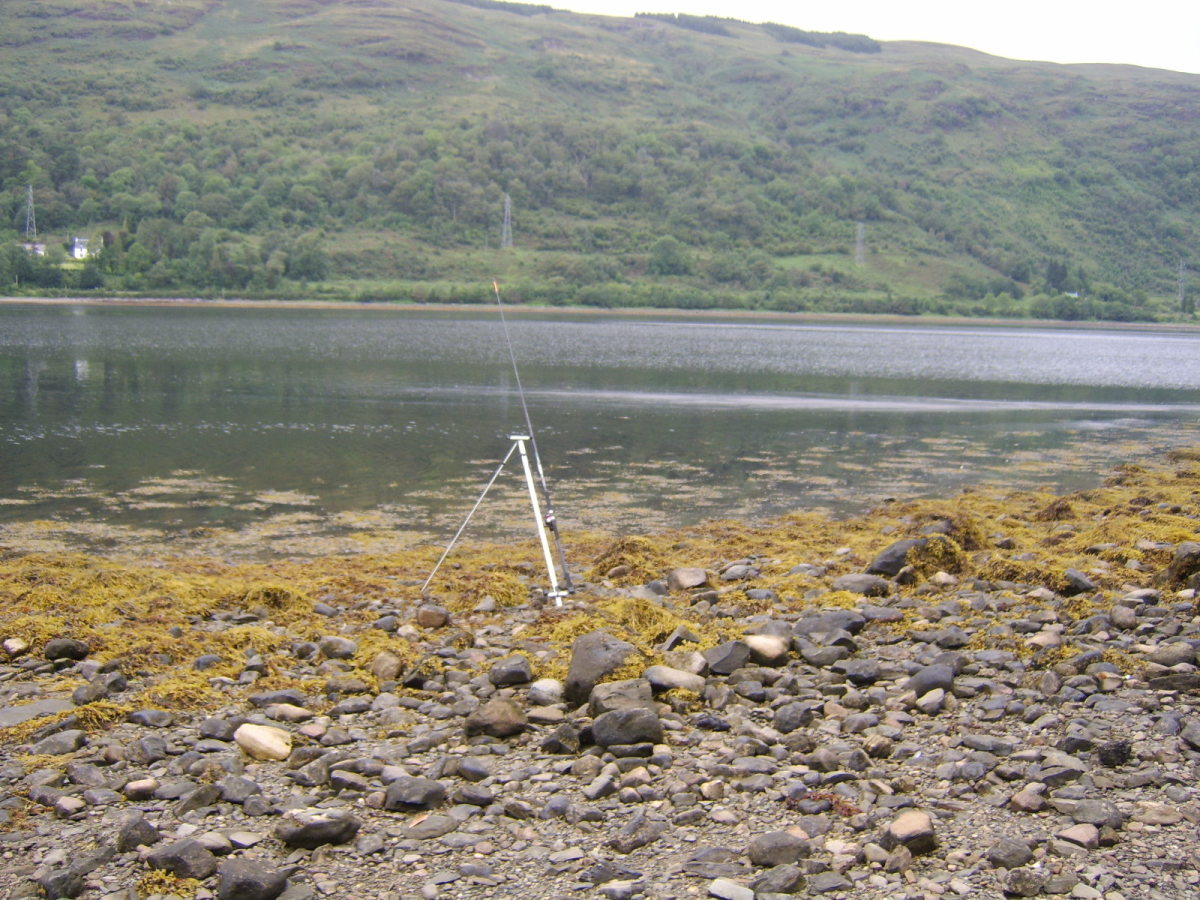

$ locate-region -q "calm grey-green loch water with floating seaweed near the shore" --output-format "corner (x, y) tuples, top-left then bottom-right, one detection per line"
(0, 305), (1200, 556)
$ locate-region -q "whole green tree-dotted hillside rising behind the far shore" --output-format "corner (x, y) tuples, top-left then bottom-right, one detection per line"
(0, 0), (1200, 318)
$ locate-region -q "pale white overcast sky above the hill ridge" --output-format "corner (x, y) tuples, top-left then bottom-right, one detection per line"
(545, 0), (1200, 73)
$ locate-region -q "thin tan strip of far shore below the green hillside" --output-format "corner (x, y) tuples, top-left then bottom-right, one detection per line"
(0, 296), (1200, 331)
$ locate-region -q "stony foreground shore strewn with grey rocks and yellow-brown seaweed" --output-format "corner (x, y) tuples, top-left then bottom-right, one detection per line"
(0, 451), (1200, 900)
